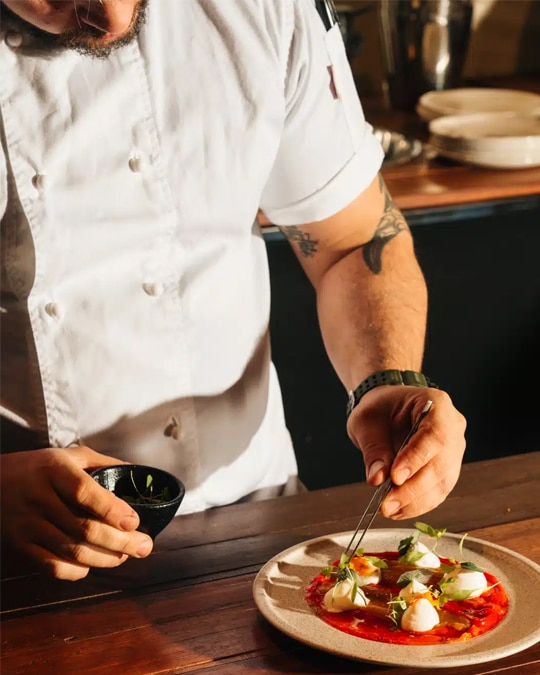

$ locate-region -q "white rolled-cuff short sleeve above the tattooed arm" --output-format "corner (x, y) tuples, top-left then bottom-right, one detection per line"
(260, 0), (383, 225)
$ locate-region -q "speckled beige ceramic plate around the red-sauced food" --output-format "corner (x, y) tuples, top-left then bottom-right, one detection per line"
(253, 528), (540, 669)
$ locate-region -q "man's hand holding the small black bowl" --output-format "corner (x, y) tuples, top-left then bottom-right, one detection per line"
(0, 447), (153, 581)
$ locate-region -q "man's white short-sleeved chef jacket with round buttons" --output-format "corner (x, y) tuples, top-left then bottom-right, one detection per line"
(0, 0), (382, 512)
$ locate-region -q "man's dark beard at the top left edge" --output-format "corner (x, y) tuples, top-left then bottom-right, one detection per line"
(0, 0), (149, 58)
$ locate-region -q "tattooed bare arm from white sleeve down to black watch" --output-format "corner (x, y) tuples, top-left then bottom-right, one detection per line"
(282, 175), (427, 390)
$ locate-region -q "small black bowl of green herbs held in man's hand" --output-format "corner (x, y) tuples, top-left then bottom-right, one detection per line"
(90, 464), (186, 539)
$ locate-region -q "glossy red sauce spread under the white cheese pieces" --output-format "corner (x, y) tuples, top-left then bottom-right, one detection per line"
(306, 551), (508, 645)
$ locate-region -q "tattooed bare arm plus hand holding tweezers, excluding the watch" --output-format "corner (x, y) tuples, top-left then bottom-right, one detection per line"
(282, 176), (465, 518)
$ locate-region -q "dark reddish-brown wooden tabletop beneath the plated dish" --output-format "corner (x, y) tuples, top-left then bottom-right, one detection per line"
(0, 452), (540, 675)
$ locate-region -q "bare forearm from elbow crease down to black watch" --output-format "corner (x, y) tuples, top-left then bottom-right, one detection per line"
(317, 229), (427, 389)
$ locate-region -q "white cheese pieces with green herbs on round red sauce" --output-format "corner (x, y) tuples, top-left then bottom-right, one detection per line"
(306, 522), (508, 645)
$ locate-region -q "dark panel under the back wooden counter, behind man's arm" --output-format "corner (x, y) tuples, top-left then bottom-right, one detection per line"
(265, 195), (540, 489)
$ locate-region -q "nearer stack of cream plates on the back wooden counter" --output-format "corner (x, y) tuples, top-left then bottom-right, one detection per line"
(429, 112), (540, 169)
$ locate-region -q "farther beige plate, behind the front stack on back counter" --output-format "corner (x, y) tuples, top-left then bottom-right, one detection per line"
(416, 87), (540, 122)
